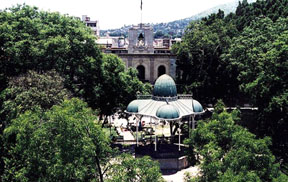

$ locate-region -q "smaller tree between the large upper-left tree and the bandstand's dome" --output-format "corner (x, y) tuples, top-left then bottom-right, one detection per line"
(99, 54), (151, 123)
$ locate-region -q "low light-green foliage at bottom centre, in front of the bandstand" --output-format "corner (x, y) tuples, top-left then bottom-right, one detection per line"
(107, 154), (164, 182)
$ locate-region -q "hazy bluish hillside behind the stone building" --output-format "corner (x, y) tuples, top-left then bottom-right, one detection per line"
(100, 0), (256, 38)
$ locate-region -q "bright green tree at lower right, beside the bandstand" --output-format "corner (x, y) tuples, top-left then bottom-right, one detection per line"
(186, 111), (286, 182)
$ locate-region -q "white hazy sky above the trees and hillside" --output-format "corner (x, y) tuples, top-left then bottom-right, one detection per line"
(0, 0), (234, 29)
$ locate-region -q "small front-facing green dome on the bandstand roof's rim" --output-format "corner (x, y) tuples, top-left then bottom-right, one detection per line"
(156, 104), (180, 119)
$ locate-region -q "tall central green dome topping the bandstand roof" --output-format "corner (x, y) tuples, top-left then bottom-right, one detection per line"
(153, 74), (177, 97)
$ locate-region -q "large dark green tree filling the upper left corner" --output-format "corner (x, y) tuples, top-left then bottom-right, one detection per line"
(0, 5), (102, 108)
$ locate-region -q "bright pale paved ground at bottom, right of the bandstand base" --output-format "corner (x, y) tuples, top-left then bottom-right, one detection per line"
(163, 166), (199, 182)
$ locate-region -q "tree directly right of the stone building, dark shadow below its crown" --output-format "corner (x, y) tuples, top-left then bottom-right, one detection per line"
(173, 11), (239, 104)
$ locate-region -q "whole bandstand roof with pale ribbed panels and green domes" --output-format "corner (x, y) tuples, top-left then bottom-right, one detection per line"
(126, 75), (204, 121)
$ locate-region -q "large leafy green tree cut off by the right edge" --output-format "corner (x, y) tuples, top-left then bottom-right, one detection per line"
(223, 18), (288, 166)
